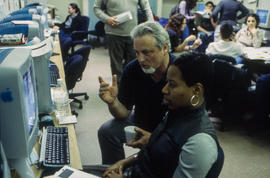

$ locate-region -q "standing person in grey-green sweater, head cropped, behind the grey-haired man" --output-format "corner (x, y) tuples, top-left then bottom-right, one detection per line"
(94, 0), (153, 83)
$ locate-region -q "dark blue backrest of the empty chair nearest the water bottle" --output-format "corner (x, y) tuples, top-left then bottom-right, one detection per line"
(64, 45), (91, 90)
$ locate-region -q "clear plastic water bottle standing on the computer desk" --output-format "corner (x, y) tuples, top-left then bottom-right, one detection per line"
(53, 79), (69, 121)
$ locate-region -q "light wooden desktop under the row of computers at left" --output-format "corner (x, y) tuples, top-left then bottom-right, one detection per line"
(32, 37), (82, 177)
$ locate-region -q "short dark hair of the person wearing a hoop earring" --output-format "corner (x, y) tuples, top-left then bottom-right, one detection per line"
(172, 52), (214, 96)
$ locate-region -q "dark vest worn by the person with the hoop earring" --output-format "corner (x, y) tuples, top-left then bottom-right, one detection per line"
(131, 106), (223, 178)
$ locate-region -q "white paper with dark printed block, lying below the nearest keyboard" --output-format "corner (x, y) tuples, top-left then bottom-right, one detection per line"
(50, 166), (99, 178)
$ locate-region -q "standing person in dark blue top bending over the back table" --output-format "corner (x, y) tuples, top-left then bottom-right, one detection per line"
(212, 0), (248, 41)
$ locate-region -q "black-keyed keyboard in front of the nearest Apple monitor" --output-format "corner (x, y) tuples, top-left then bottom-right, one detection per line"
(40, 126), (70, 167)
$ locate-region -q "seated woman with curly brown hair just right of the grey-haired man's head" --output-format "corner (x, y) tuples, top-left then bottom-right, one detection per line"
(165, 14), (200, 52)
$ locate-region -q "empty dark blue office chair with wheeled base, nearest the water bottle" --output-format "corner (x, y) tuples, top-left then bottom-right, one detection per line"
(64, 45), (91, 109)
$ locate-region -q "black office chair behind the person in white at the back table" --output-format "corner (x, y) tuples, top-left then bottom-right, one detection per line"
(207, 59), (252, 131)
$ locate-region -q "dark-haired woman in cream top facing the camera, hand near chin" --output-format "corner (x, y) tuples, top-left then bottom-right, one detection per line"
(235, 14), (263, 48)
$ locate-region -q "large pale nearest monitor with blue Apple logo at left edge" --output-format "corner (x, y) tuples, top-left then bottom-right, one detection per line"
(0, 48), (39, 177)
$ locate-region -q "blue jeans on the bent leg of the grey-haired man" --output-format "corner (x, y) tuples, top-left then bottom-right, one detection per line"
(98, 113), (134, 164)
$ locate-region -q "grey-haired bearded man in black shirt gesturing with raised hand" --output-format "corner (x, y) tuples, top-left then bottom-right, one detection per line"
(98, 22), (175, 164)
